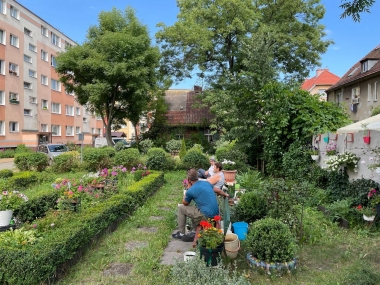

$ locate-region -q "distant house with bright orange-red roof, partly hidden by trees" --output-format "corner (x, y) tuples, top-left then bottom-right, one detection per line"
(301, 68), (340, 101)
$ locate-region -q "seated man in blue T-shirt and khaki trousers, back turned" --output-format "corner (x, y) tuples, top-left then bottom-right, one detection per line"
(172, 169), (219, 241)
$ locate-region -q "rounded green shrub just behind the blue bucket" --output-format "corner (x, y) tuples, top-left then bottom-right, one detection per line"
(234, 191), (268, 223)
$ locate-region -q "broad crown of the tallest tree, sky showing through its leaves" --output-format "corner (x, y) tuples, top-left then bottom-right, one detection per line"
(156, 0), (331, 84)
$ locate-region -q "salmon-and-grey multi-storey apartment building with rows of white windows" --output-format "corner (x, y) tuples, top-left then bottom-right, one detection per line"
(0, 0), (104, 149)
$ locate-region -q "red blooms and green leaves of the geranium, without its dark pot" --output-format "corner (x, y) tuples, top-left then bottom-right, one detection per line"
(198, 216), (224, 248)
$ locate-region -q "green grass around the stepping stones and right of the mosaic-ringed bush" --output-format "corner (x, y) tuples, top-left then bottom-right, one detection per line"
(59, 172), (380, 285)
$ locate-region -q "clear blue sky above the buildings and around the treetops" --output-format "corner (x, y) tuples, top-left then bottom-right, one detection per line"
(17, 0), (380, 89)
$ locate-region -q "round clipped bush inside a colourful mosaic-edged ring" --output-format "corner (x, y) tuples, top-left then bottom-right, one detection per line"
(246, 218), (296, 263)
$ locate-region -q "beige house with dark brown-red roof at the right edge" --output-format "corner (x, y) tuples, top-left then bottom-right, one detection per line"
(326, 45), (380, 122)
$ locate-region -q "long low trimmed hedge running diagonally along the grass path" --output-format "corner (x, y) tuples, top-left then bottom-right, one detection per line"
(0, 172), (164, 285)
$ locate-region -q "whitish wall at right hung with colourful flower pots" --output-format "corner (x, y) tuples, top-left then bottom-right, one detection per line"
(314, 130), (380, 183)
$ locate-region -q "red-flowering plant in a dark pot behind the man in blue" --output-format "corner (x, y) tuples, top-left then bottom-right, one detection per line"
(198, 216), (224, 266)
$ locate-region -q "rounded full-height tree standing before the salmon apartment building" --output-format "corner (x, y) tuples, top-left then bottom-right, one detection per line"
(56, 8), (160, 145)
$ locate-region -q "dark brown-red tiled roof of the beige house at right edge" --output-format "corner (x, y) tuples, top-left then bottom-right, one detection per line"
(328, 46), (380, 91)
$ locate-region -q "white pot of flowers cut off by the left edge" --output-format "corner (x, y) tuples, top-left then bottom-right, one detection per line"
(0, 191), (28, 227)
